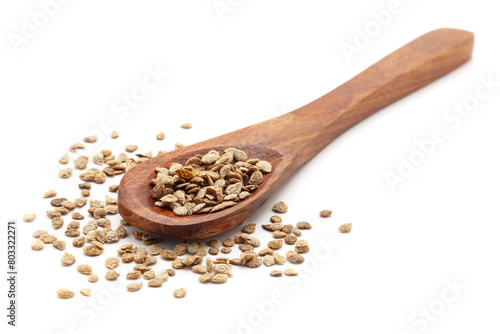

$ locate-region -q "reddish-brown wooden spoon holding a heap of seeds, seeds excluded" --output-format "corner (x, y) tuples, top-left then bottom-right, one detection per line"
(118, 28), (474, 239)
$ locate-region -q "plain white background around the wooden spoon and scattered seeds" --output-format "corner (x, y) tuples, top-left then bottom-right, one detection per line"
(0, 0), (500, 334)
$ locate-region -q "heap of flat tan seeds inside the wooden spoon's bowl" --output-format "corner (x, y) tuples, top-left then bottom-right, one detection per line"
(151, 148), (272, 216)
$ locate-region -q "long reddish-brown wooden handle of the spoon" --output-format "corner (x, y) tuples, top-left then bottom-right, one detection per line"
(252, 28), (474, 169)
